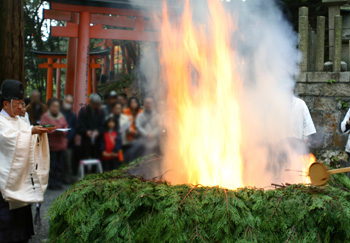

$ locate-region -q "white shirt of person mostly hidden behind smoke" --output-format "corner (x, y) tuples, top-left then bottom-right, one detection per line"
(289, 97), (316, 139)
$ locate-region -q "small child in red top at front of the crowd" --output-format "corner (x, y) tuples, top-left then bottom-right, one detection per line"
(101, 116), (123, 171)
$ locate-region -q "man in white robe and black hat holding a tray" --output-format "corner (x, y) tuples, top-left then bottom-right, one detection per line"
(0, 80), (49, 242)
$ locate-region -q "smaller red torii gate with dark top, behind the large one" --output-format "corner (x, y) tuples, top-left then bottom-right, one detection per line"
(32, 49), (109, 101)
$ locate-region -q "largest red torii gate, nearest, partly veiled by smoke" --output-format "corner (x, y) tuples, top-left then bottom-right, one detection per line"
(44, 0), (167, 112)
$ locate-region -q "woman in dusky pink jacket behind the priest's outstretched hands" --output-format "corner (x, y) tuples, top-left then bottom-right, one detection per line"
(40, 98), (68, 190)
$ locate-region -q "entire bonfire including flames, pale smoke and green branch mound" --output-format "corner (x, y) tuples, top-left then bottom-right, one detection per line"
(49, 0), (350, 242)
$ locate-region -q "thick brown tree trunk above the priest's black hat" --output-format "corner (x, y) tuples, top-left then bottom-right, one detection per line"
(0, 0), (24, 85)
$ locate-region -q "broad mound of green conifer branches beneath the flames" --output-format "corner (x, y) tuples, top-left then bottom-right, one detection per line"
(49, 157), (350, 242)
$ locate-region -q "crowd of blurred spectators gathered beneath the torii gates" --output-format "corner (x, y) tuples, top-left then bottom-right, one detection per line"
(22, 91), (161, 190)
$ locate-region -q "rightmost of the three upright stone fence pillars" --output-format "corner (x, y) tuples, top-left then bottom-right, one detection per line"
(333, 15), (343, 72)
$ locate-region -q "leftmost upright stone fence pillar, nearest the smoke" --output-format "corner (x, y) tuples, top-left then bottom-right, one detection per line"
(298, 7), (309, 72)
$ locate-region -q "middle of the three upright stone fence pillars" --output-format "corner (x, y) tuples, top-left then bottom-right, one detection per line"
(316, 16), (326, 72)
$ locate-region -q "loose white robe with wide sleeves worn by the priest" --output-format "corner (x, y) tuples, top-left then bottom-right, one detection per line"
(0, 110), (50, 209)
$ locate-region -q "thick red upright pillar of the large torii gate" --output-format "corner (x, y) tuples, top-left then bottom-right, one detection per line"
(74, 12), (91, 112)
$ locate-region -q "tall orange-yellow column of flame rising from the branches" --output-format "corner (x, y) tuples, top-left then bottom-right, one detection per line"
(160, 0), (244, 189)
